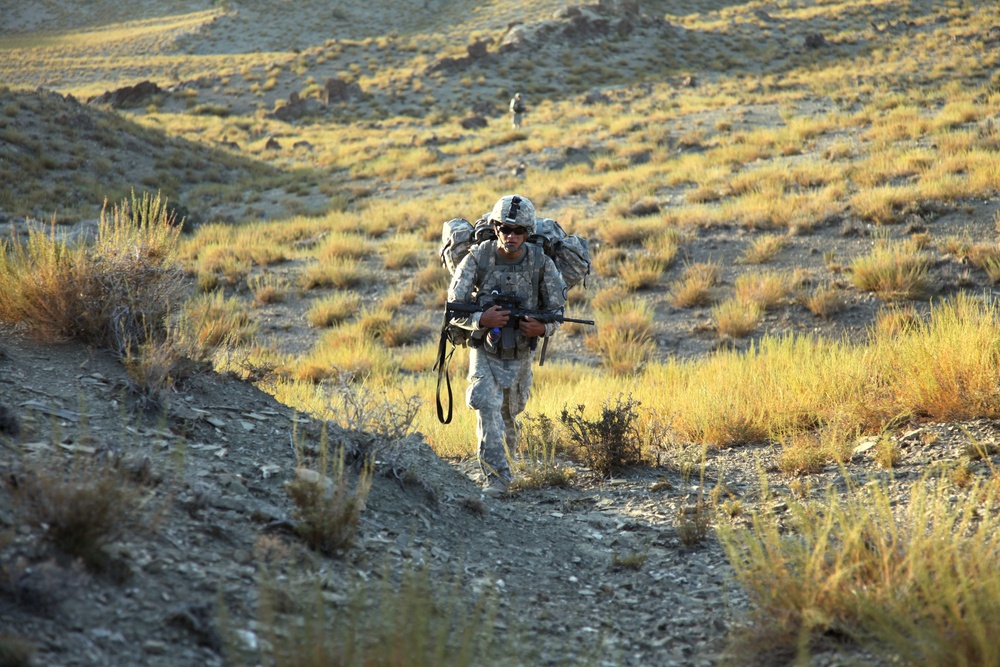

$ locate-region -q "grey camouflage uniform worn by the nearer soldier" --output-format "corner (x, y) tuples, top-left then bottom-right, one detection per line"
(448, 241), (566, 485)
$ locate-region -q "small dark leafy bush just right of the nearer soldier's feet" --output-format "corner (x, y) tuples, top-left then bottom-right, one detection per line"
(560, 395), (643, 477)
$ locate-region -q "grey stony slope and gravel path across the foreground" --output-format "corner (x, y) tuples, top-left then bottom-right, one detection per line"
(0, 331), (1000, 667)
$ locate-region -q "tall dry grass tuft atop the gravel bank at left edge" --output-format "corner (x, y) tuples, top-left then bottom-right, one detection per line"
(0, 194), (183, 356)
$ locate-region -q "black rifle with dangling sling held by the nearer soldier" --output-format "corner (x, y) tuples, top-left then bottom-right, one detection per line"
(434, 292), (596, 424)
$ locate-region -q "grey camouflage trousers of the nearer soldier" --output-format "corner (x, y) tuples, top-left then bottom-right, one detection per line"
(466, 350), (532, 482)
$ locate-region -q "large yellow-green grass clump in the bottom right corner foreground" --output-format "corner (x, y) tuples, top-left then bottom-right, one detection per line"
(721, 479), (997, 665)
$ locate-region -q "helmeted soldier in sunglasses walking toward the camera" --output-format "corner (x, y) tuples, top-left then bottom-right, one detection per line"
(448, 195), (566, 497)
